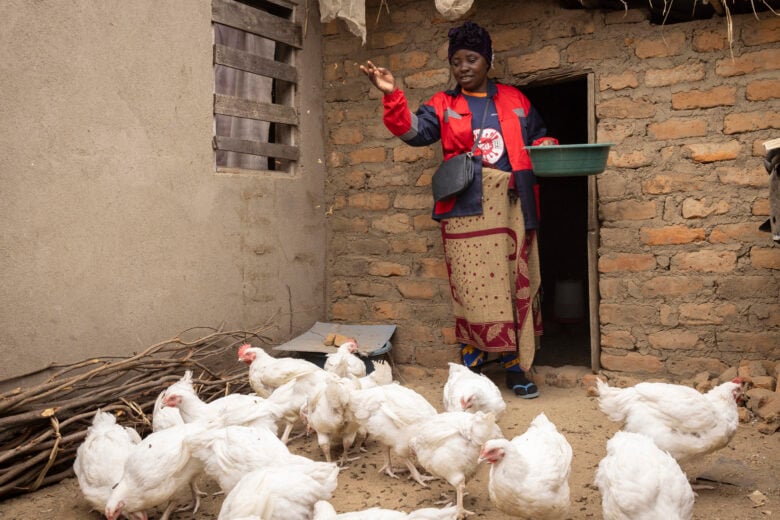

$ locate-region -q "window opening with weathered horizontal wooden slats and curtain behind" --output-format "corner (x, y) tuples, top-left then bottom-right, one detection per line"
(212, 0), (303, 173)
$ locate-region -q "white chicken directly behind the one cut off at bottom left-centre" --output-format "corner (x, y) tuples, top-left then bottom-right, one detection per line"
(185, 425), (333, 493)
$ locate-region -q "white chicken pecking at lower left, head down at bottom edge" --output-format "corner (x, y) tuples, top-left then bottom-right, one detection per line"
(105, 423), (203, 520)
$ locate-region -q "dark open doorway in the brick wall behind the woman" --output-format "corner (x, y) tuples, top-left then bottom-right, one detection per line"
(520, 75), (598, 369)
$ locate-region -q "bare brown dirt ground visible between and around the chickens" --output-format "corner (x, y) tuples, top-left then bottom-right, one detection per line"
(0, 369), (780, 520)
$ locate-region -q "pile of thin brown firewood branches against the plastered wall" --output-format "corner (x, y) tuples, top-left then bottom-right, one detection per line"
(0, 326), (268, 500)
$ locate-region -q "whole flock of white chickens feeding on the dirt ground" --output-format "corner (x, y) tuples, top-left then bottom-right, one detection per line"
(74, 341), (741, 520)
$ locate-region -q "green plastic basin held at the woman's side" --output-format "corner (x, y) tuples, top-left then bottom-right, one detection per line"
(525, 143), (614, 177)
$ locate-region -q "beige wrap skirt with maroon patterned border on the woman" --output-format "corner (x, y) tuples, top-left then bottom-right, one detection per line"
(440, 167), (542, 370)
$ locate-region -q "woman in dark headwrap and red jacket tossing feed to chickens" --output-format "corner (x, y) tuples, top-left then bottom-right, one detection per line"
(360, 22), (557, 399)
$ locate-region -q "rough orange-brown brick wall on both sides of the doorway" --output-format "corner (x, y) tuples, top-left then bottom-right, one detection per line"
(324, 0), (780, 376)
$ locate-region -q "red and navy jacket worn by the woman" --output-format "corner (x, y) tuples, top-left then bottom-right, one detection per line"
(382, 81), (547, 229)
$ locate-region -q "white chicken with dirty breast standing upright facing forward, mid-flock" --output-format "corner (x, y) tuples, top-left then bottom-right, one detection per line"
(301, 378), (362, 466)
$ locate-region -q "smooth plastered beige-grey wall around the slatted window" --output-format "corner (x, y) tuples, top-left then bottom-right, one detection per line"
(0, 0), (325, 380)
